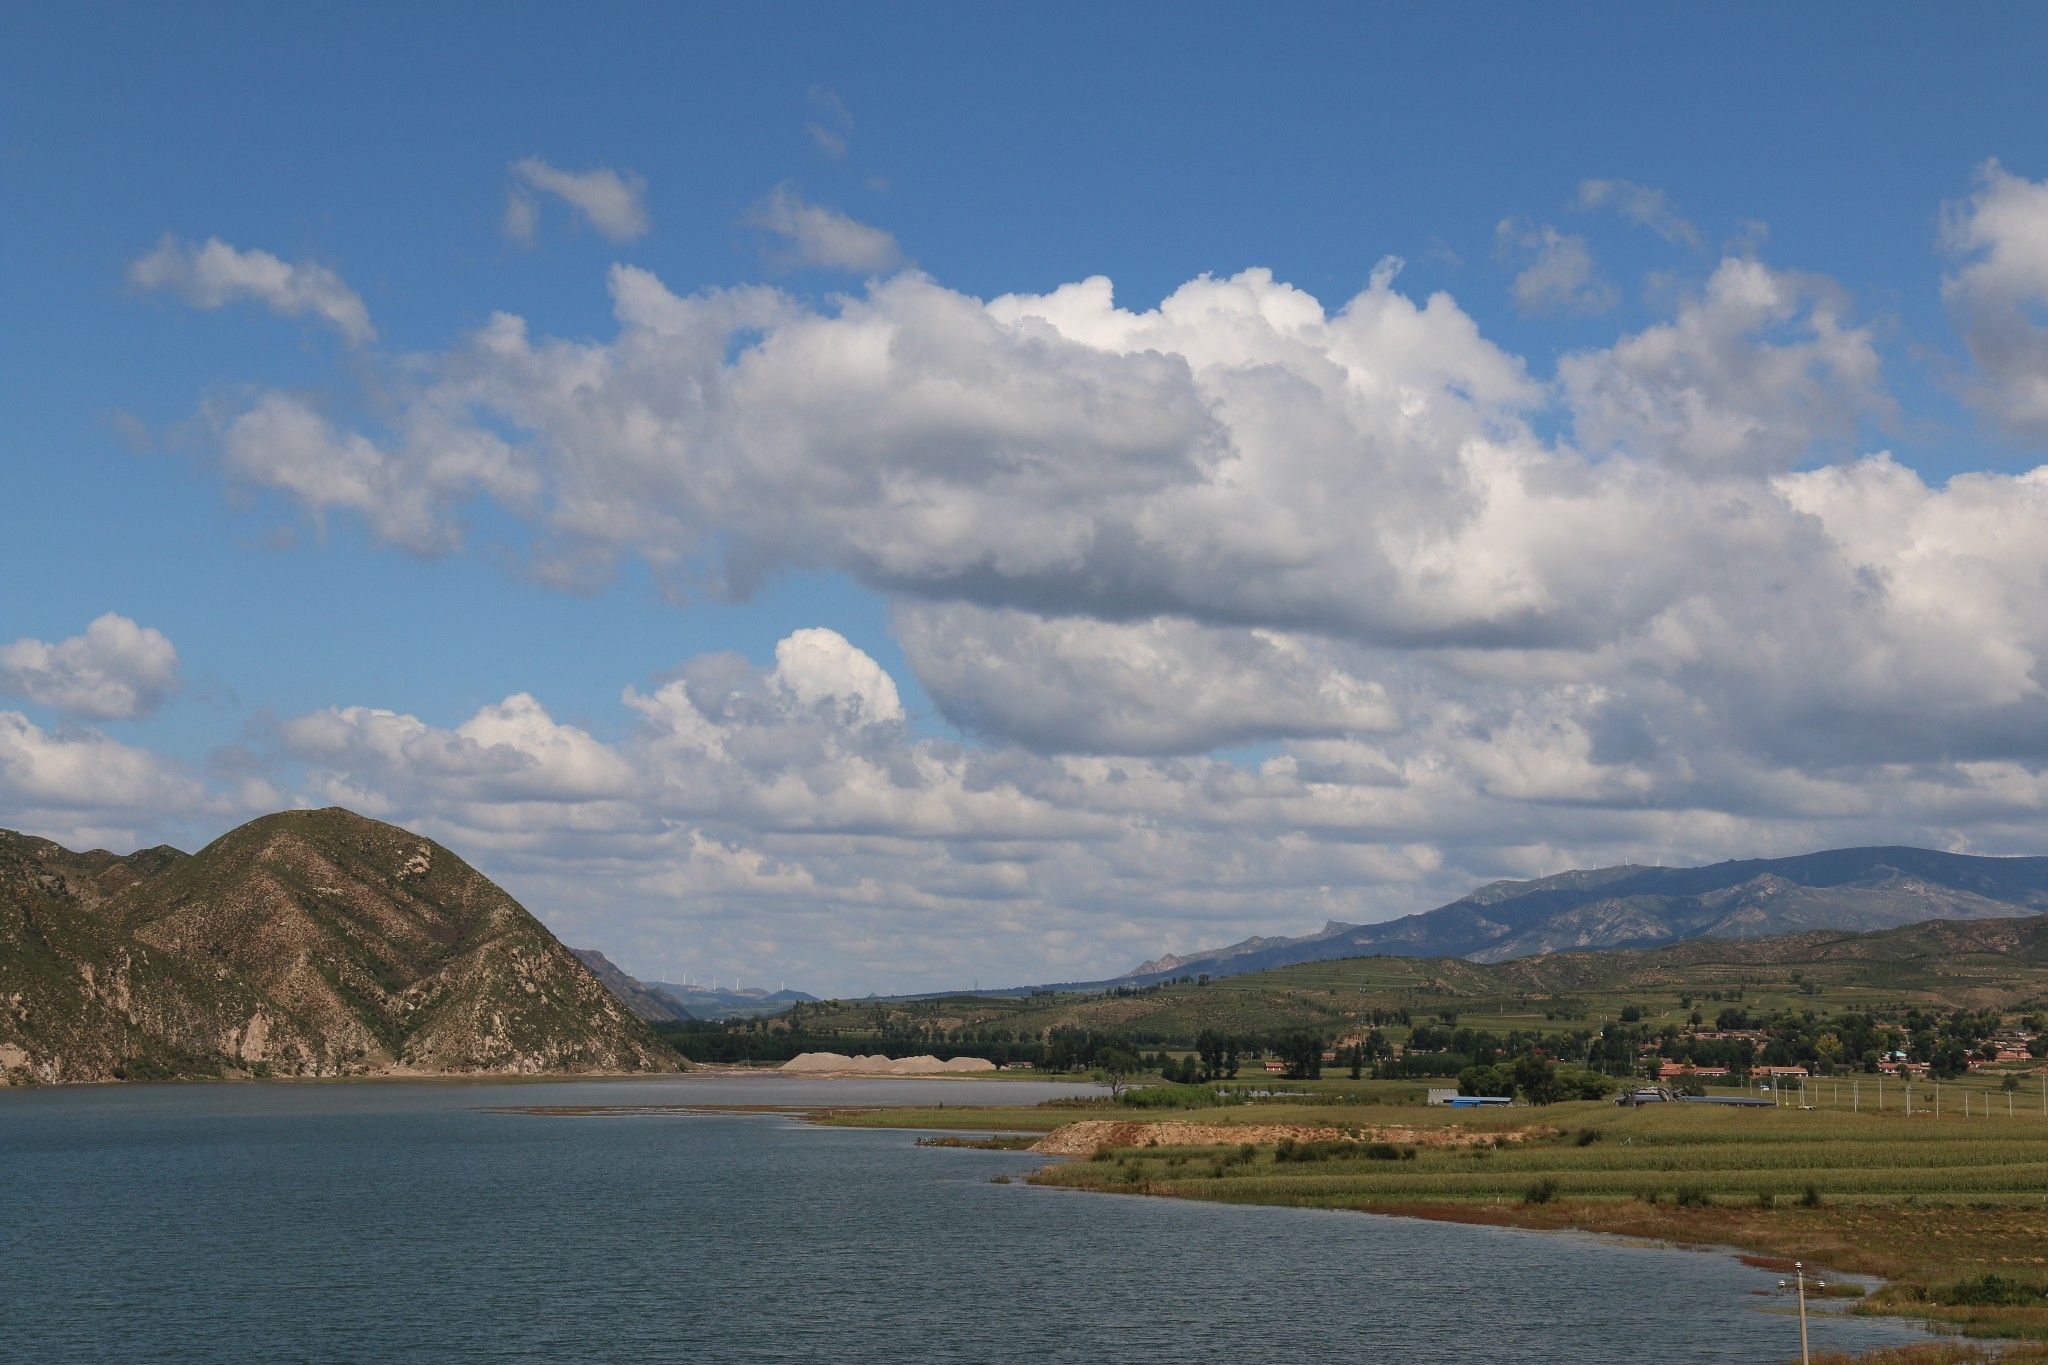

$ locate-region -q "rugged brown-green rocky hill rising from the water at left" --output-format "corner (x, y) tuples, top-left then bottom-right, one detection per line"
(0, 810), (676, 1081)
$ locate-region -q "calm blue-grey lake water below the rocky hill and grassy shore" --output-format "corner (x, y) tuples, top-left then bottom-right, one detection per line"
(0, 1078), (1921, 1365)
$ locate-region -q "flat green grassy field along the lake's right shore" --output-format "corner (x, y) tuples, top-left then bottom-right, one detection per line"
(827, 1081), (2048, 1359)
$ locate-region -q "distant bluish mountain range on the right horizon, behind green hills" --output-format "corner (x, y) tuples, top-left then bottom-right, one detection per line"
(1116, 847), (2048, 984)
